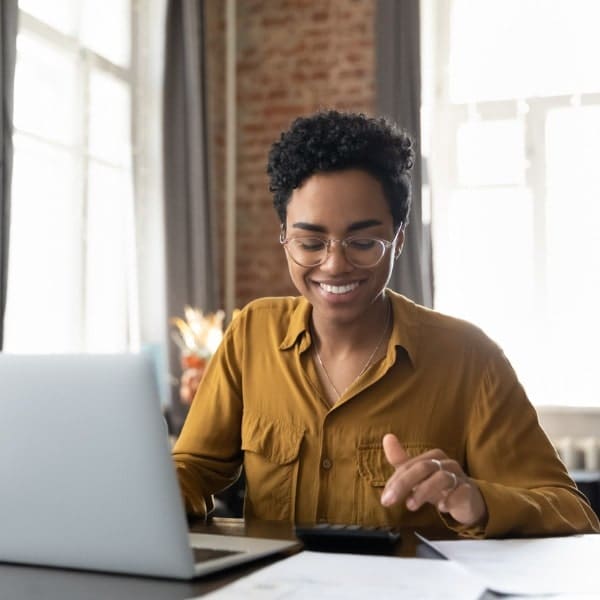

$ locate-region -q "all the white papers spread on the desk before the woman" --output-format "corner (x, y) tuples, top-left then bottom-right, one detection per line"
(191, 534), (600, 600)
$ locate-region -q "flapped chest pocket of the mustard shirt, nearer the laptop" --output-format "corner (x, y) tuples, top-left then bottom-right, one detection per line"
(242, 414), (304, 521)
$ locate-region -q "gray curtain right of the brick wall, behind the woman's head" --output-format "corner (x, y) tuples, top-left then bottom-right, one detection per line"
(376, 0), (433, 307)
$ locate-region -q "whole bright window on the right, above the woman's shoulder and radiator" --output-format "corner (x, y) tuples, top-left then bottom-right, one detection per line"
(423, 0), (600, 406)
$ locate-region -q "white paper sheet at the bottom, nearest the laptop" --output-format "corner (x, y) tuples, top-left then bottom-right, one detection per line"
(197, 551), (485, 600)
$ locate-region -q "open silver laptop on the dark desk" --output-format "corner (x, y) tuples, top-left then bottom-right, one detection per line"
(0, 353), (297, 579)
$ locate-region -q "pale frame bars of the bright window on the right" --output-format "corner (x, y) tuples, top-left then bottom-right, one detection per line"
(422, 0), (600, 410)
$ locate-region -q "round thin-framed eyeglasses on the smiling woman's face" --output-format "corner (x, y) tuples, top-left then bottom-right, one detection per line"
(279, 227), (402, 268)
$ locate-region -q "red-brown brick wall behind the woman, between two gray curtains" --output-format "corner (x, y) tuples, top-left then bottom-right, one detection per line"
(205, 0), (376, 306)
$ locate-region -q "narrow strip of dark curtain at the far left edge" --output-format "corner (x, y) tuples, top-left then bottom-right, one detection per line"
(0, 0), (19, 350)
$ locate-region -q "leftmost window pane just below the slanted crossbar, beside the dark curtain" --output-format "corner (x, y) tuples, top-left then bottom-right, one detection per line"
(14, 33), (80, 145)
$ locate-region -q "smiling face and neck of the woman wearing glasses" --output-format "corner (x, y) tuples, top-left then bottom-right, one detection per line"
(284, 169), (404, 332)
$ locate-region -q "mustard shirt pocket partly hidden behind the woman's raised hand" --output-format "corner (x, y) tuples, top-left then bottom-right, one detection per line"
(355, 442), (440, 527)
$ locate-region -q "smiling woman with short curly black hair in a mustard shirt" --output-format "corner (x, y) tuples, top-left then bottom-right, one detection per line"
(174, 111), (599, 537)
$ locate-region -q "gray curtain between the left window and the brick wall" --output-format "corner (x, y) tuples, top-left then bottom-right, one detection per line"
(163, 0), (220, 428)
